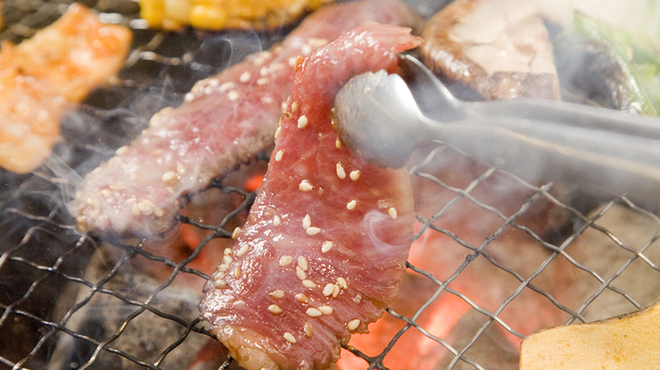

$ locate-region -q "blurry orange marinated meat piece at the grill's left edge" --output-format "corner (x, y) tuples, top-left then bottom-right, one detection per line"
(0, 4), (131, 173)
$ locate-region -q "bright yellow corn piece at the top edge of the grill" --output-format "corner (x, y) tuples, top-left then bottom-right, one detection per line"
(139, 0), (334, 30)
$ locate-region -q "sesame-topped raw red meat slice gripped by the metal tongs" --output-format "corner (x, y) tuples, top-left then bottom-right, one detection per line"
(199, 25), (421, 369)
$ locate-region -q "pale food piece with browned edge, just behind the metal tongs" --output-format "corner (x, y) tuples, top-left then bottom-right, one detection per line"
(422, 0), (560, 100)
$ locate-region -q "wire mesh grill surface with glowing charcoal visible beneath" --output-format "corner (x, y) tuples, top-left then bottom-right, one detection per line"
(0, 0), (660, 369)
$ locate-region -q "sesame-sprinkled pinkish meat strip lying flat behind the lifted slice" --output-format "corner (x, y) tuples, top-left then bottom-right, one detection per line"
(70, 0), (417, 236)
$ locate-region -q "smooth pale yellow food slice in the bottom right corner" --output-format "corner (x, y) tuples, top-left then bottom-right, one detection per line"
(520, 301), (660, 370)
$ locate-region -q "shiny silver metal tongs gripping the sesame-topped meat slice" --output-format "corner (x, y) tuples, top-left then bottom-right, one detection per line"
(335, 56), (660, 206)
